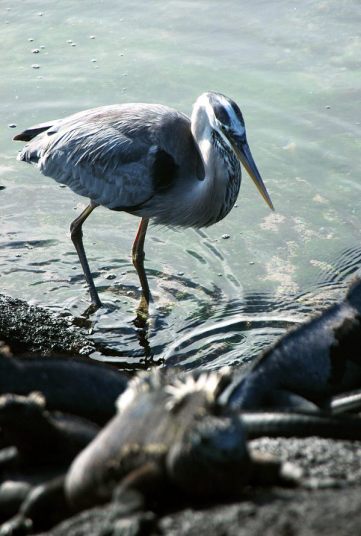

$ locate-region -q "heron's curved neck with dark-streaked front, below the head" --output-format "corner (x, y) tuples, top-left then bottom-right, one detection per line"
(192, 121), (241, 227)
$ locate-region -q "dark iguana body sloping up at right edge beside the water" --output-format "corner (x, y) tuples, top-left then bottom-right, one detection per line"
(223, 280), (361, 410)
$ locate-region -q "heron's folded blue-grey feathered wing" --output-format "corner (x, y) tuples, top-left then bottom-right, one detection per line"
(18, 104), (186, 209)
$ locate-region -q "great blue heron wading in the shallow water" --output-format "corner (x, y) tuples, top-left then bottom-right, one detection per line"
(14, 92), (273, 308)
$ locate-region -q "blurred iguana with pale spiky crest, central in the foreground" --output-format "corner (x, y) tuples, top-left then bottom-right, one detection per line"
(0, 370), (361, 534)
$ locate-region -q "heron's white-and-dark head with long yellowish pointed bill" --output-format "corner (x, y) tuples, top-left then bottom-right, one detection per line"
(192, 92), (273, 210)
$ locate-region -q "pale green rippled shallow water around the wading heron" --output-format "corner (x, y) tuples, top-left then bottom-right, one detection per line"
(0, 0), (361, 368)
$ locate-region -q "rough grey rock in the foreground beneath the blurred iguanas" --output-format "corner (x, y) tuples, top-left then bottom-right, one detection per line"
(40, 437), (361, 536)
